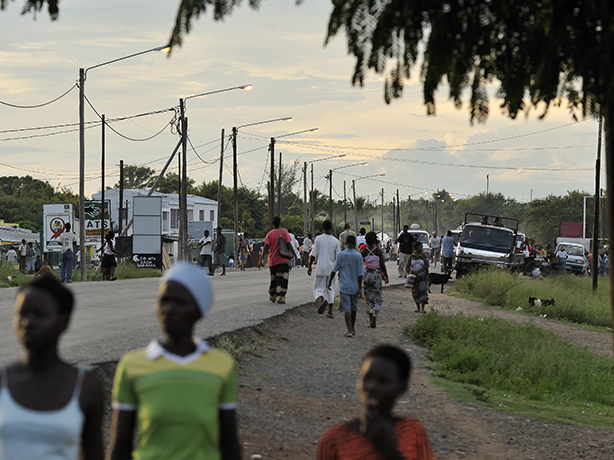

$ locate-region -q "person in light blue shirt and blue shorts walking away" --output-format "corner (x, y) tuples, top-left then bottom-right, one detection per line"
(328, 235), (366, 337)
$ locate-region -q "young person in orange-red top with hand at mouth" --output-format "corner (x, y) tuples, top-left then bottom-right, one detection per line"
(316, 345), (435, 460)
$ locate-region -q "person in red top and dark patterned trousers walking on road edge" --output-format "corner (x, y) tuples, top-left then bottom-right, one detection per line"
(258, 216), (294, 304)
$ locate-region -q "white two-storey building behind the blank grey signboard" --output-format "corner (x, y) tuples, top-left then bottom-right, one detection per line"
(92, 188), (218, 238)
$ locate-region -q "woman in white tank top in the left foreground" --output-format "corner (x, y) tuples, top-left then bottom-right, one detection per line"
(0, 276), (104, 460)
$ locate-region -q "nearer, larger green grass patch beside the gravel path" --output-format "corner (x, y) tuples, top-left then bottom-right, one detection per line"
(404, 312), (614, 428)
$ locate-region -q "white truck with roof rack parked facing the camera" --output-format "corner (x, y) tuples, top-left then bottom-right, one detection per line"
(455, 213), (524, 278)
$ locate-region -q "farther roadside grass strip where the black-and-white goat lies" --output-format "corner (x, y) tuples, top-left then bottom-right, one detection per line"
(452, 270), (612, 328)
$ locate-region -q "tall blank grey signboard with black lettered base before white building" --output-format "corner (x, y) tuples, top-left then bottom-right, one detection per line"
(132, 196), (162, 268)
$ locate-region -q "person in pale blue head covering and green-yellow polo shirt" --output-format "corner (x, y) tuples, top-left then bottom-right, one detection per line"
(108, 263), (241, 460)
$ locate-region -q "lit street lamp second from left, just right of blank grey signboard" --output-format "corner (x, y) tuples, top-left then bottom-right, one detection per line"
(179, 85), (253, 261)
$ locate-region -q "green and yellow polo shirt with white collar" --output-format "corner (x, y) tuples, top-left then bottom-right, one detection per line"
(113, 341), (236, 460)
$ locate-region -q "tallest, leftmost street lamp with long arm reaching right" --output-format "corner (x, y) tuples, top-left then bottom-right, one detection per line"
(79, 45), (171, 281)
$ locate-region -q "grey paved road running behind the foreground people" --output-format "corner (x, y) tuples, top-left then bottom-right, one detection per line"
(0, 262), (404, 366)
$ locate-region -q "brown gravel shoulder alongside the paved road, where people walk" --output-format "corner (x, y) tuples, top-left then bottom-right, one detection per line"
(96, 285), (614, 460)
